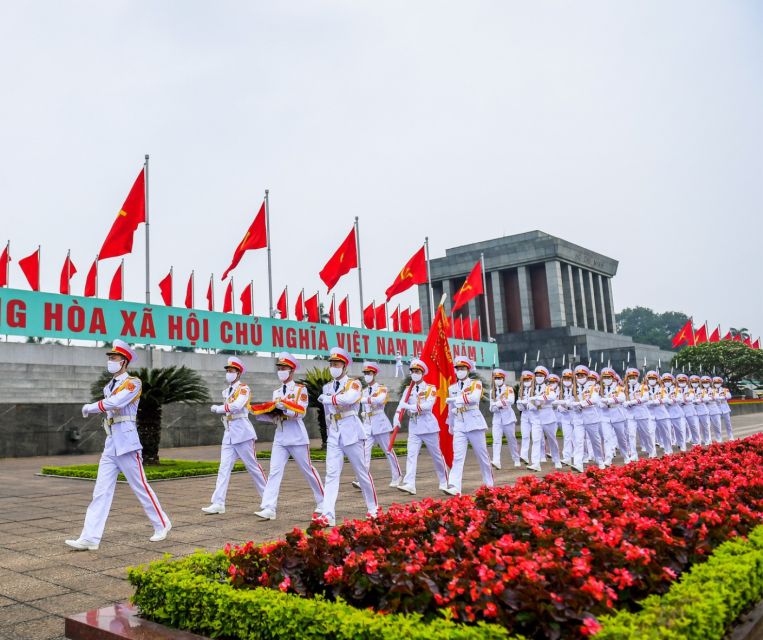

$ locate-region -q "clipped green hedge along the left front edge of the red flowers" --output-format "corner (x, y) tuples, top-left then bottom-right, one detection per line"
(128, 552), (519, 640)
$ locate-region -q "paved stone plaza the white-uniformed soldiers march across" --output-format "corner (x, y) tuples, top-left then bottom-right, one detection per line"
(0, 414), (763, 640)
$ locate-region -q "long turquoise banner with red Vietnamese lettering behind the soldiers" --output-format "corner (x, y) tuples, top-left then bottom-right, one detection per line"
(0, 289), (498, 367)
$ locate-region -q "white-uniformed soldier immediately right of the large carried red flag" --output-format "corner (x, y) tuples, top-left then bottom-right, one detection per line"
(445, 356), (493, 496)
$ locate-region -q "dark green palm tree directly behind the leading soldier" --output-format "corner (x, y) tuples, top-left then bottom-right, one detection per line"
(90, 366), (210, 464)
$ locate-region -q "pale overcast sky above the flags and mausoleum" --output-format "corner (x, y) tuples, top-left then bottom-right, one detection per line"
(0, 0), (763, 338)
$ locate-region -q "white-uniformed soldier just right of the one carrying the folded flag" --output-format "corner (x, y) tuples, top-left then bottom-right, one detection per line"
(318, 347), (379, 526)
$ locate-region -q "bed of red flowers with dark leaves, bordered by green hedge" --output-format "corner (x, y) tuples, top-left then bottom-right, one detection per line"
(226, 435), (763, 638)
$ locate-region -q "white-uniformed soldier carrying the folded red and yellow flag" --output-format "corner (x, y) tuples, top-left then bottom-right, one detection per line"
(254, 351), (323, 520)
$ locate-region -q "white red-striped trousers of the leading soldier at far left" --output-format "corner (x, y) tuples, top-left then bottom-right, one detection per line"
(80, 451), (169, 544)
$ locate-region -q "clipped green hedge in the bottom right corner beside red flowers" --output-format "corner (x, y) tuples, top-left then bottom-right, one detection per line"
(596, 526), (763, 640)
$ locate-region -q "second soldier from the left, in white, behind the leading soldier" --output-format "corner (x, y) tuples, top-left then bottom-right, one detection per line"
(201, 356), (267, 515)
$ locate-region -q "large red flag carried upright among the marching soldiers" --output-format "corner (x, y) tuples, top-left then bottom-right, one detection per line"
(421, 305), (456, 467)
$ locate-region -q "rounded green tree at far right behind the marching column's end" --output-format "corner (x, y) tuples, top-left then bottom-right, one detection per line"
(672, 340), (763, 394)
